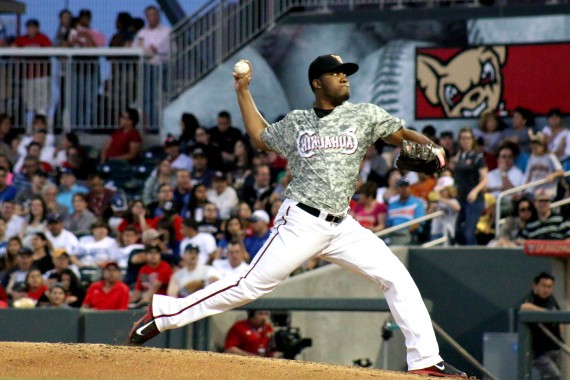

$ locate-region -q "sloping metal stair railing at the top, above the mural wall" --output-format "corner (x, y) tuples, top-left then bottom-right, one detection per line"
(168, 0), (480, 99)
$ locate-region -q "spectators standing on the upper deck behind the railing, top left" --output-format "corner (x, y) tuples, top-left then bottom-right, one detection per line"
(0, 5), (171, 127)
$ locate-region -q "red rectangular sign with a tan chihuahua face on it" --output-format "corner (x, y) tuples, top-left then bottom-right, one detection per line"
(416, 43), (570, 119)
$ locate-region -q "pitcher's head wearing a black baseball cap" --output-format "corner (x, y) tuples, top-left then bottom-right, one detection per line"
(309, 54), (358, 105)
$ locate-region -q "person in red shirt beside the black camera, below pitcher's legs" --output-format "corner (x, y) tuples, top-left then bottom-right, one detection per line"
(224, 310), (274, 357)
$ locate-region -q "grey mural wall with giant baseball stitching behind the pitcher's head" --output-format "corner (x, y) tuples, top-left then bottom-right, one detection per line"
(164, 15), (570, 138)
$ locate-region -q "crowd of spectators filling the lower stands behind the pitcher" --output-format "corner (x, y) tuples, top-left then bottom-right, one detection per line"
(0, 104), (570, 310)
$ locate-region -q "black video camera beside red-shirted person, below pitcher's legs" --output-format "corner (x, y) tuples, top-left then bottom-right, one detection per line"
(271, 312), (313, 360)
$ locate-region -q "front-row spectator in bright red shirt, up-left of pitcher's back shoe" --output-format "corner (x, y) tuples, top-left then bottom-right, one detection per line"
(81, 262), (129, 310)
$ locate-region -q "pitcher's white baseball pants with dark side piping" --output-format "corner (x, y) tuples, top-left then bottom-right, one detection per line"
(152, 200), (442, 370)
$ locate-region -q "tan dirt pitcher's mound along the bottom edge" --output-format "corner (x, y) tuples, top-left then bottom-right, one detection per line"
(0, 342), (426, 380)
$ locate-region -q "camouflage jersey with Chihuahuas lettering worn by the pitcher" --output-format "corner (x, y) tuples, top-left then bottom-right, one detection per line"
(262, 102), (404, 214)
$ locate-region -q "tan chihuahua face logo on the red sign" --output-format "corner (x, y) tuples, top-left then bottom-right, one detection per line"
(416, 46), (507, 117)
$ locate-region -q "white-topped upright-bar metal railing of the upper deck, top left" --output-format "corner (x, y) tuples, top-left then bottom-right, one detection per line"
(0, 48), (165, 132)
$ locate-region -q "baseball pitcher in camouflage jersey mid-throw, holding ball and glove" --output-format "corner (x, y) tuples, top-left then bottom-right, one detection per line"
(129, 54), (467, 378)
